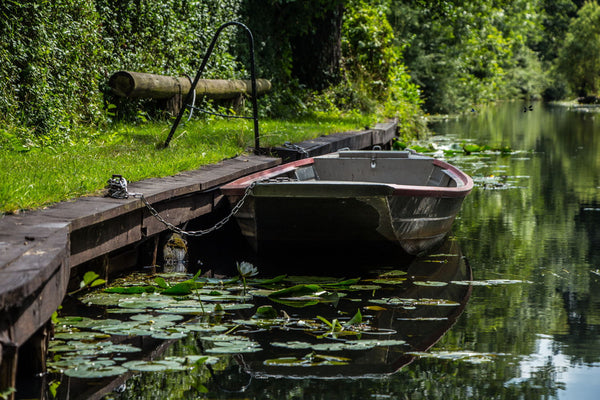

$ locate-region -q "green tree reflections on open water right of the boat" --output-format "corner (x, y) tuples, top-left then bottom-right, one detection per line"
(434, 103), (600, 399)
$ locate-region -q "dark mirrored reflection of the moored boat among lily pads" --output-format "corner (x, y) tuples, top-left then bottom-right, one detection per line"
(241, 241), (472, 379)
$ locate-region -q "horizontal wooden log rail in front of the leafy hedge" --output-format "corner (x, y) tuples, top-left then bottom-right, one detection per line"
(108, 71), (271, 99)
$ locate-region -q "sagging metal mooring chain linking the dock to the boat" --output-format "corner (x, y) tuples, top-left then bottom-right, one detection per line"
(108, 175), (261, 237)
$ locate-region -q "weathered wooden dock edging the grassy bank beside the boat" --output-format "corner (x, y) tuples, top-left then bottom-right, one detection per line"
(0, 122), (396, 392)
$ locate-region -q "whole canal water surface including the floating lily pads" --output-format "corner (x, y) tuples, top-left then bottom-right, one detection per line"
(43, 103), (600, 400)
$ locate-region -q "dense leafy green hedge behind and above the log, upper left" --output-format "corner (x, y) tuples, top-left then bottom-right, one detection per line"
(0, 0), (243, 138)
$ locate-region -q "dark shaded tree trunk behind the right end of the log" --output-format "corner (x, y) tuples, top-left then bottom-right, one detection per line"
(242, 0), (344, 90)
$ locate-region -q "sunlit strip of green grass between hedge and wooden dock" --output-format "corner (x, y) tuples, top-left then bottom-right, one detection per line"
(0, 115), (375, 214)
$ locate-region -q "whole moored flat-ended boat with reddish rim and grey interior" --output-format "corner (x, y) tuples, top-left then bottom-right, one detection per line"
(221, 150), (473, 255)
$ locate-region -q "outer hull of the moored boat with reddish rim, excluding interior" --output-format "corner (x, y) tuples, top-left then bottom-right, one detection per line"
(222, 150), (472, 255)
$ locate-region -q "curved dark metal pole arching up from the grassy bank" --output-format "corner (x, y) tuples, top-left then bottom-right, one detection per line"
(164, 21), (260, 154)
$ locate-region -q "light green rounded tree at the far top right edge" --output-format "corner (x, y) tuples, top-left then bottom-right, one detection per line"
(558, 1), (600, 96)
